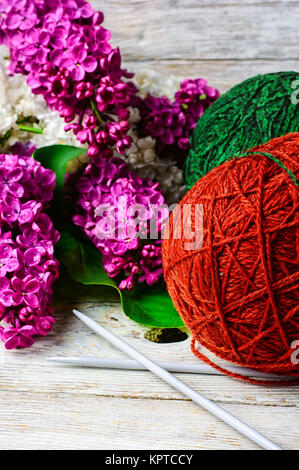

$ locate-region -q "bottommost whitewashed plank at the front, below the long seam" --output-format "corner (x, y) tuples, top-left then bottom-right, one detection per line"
(0, 392), (299, 449)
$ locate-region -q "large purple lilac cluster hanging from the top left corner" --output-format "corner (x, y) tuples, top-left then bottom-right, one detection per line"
(0, 0), (137, 157)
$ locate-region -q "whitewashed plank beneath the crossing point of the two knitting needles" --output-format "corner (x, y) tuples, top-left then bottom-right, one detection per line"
(0, 303), (299, 407)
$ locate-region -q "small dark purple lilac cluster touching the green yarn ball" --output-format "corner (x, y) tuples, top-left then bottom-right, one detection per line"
(139, 78), (219, 156)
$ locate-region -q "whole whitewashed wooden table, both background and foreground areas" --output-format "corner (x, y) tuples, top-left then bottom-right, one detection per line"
(0, 0), (299, 449)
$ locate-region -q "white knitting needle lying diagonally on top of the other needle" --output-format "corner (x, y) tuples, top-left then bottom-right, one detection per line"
(73, 310), (282, 450)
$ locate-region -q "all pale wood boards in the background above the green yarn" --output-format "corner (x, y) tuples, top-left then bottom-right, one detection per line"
(92, 0), (299, 93)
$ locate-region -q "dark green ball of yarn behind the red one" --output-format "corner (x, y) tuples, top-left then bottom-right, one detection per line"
(185, 72), (299, 189)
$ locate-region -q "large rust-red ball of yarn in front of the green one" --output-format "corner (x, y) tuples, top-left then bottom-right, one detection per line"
(162, 133), (299, 383)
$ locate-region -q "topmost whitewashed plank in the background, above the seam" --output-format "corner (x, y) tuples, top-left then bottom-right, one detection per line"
(93, 0), (299, 61)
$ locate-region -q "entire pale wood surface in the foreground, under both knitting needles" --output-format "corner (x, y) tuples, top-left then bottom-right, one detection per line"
(0, 302), (299, 449)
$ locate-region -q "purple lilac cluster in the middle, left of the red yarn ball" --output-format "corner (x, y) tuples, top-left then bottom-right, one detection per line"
(73, 158), (168, 289)
